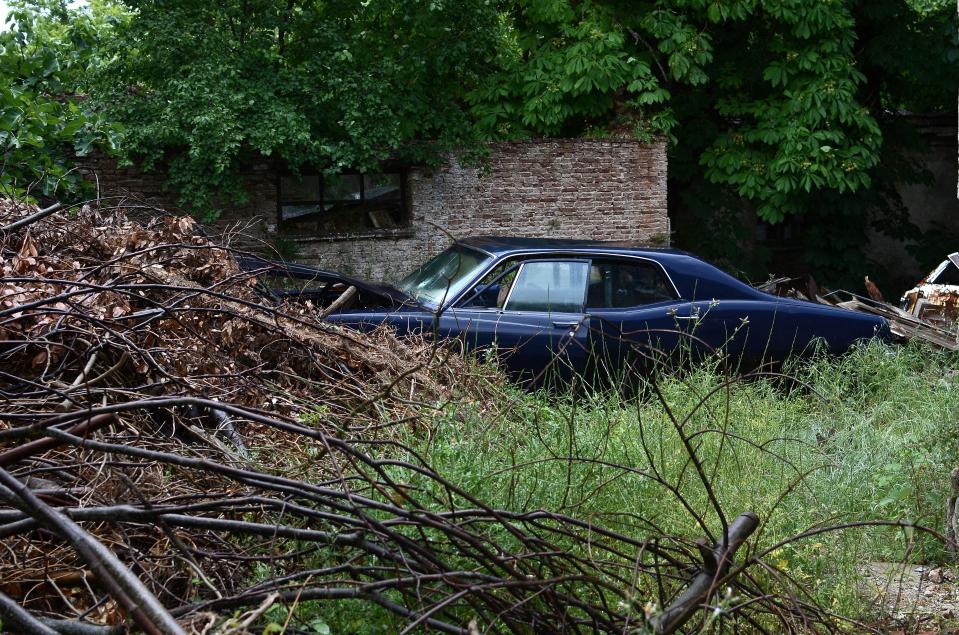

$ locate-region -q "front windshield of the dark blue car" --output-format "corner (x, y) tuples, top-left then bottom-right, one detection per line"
(396, 245), (492, 306)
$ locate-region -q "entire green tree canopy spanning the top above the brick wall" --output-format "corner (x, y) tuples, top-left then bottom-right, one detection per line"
(4, 0), (959, 284)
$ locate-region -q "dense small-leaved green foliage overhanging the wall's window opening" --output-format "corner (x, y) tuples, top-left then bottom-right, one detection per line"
(96, 0), (501, 219)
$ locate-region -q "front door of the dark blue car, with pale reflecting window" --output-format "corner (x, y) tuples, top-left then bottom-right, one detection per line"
(439, 259), (589, 385)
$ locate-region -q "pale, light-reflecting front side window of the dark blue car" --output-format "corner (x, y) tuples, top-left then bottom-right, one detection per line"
(504, 260), (589, 313)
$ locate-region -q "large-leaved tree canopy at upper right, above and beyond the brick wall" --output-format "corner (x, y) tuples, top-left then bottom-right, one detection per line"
(470, 0), (959, 222)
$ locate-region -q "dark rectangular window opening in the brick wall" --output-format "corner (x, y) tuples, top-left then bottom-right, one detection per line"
(277, 170), (410, 236)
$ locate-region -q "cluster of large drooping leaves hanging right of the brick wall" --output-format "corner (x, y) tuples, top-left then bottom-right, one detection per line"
(700, 3), (881, 222)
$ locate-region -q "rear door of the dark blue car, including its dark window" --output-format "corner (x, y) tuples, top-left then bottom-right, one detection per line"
(586, 257), (702, 377)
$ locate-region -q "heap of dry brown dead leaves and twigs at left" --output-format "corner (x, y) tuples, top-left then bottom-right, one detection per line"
(0, 199), (498, 624)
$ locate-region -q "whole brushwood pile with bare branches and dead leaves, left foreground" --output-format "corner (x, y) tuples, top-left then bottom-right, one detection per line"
(0, 200), (896, 635)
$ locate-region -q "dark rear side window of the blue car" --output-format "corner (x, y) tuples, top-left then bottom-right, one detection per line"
(586, 260), (677, 309)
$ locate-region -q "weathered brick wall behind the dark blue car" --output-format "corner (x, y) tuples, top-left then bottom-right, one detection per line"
(80, 139), (669, 280)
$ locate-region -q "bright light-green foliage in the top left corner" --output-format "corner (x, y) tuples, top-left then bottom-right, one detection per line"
(0, 1), (119, 200)
